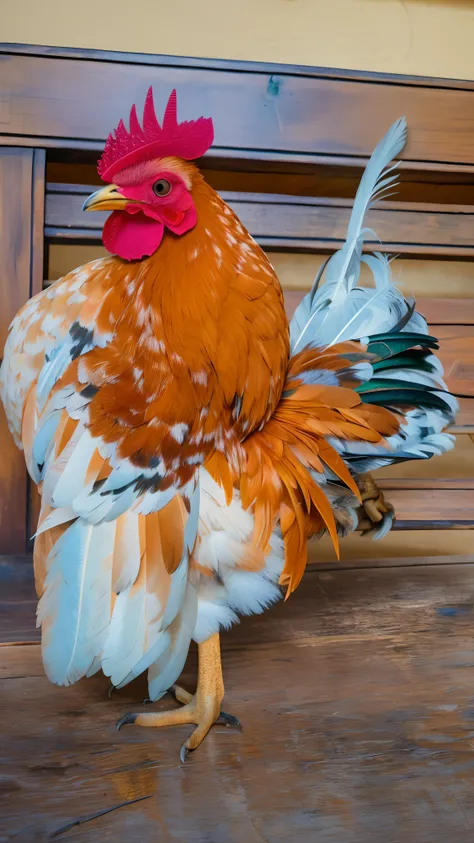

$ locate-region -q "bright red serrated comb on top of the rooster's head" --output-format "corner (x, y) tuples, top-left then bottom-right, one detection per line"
(97, 86), (214, 181)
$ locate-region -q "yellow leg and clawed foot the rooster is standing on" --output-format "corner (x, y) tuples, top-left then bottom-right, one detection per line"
(117, 633), (240, 761)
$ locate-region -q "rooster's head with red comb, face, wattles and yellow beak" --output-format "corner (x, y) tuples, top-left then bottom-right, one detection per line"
(83, 88), (214, 260)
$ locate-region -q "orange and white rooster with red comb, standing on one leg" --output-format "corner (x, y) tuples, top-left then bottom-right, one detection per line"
(1, 88), (456, 759)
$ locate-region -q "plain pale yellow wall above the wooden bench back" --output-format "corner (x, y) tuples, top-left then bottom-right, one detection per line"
(0, 0), (474, 79)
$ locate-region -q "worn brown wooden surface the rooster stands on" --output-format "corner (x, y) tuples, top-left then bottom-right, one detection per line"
(0, 557), (474, 843)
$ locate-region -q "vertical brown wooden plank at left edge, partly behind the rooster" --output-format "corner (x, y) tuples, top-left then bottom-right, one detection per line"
(0, 148), (45, 553)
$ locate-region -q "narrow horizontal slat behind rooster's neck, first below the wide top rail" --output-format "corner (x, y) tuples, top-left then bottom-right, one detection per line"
(46, 184), (474, 256)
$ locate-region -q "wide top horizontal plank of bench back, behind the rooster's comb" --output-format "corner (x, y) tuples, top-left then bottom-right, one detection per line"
(1, 47), (474, 169)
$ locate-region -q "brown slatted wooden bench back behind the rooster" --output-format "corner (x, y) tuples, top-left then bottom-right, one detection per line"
(0, 45), (474, 554)
